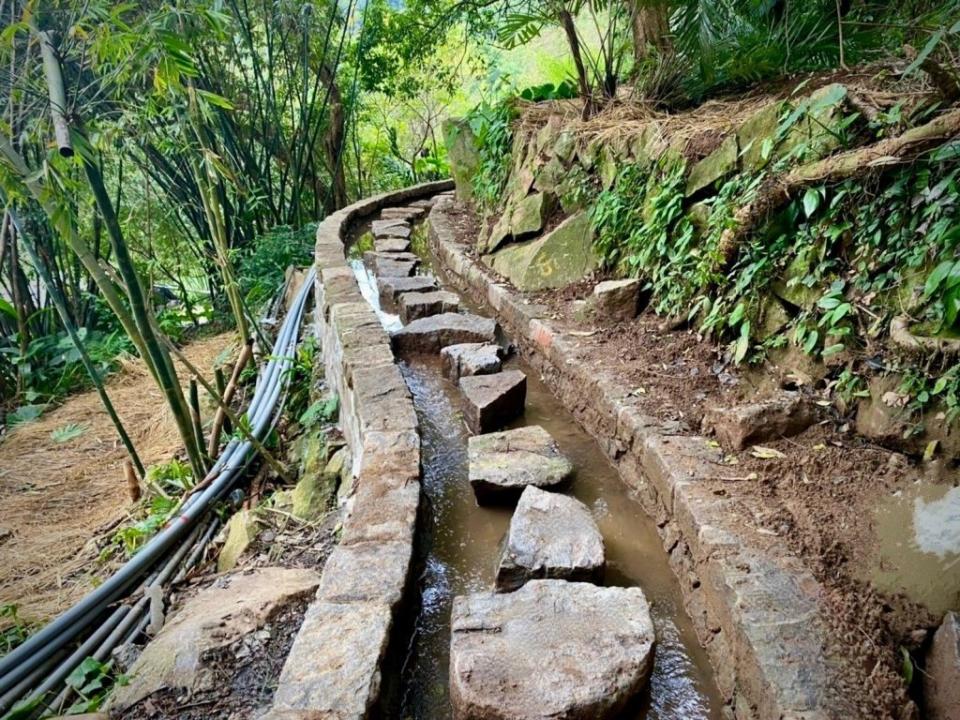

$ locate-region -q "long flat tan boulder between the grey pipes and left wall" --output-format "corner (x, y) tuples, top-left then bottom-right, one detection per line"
(108, 567), (320, 716)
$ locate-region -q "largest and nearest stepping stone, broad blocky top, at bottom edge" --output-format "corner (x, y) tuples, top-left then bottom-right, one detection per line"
(450, 580), (654, 720)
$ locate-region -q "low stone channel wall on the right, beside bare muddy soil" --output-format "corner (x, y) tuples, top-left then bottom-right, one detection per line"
(429, 195), (859, 720)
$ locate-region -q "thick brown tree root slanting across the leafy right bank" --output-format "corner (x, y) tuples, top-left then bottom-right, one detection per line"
(717, 110), (960, 268)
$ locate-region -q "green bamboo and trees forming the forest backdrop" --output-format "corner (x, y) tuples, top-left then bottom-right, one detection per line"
(0, 0), (960, 462)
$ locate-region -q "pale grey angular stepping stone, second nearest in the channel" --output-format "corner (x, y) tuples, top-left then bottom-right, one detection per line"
(496, 485), (604, 592)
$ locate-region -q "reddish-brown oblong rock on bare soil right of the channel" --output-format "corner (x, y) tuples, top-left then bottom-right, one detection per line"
(703, 392), (817, 450)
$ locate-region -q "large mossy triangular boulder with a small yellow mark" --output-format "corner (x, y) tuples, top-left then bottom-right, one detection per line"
(492, 212), (598, 292)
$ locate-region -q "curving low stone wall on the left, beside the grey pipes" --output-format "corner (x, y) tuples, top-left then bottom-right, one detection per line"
(265, 181), (453, 720)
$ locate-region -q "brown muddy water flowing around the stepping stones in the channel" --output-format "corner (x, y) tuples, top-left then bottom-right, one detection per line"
(352, 221), (721, 720)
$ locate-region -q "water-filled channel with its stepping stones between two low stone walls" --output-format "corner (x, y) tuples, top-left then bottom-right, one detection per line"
(348, 188), (722, 719)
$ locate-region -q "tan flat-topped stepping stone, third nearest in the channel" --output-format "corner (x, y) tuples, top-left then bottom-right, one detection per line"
(460, 422), (573, 500)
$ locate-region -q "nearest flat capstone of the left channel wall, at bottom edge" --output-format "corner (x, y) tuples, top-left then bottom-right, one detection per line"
(268, 602), (391, 720)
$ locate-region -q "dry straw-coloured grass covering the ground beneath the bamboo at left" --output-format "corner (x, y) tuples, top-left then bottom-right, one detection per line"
(0, 334), (235, 621)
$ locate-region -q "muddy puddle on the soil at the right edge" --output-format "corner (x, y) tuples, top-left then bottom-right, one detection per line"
(869, 481), (960, 614)
